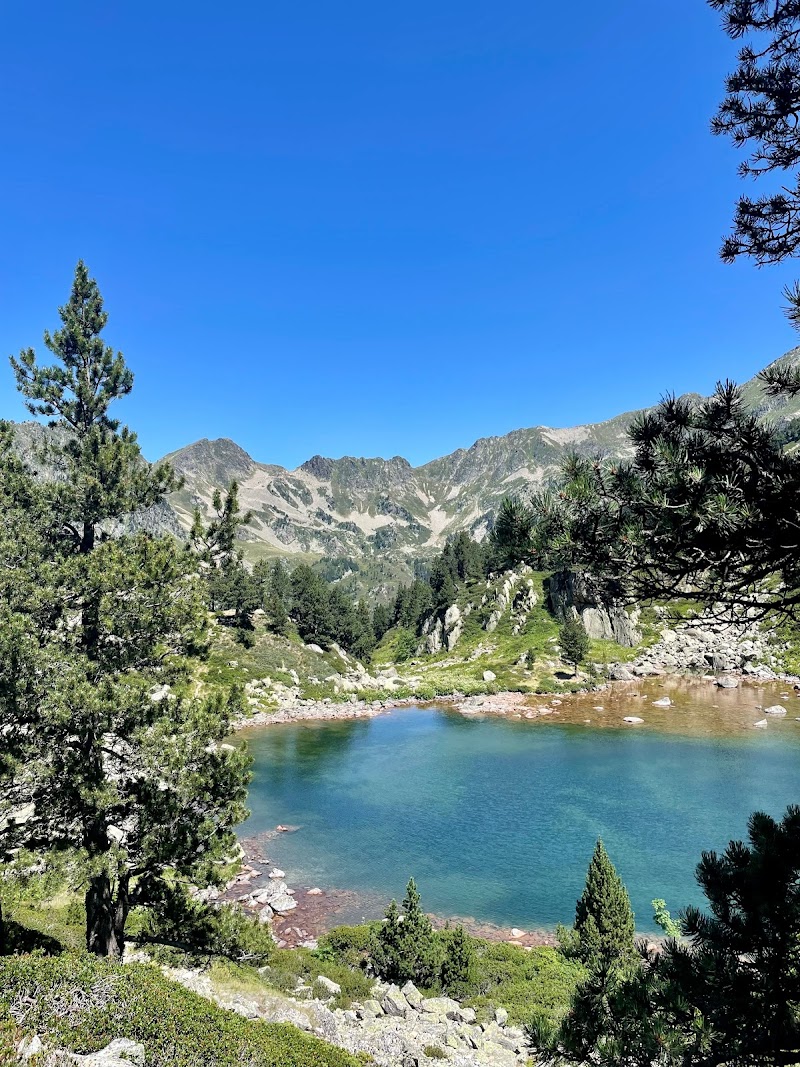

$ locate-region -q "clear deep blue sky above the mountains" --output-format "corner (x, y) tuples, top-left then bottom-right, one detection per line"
(0, 0), (800, 466)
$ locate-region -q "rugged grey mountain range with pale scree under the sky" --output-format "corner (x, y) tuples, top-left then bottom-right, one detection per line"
(10, 348), (800, 585)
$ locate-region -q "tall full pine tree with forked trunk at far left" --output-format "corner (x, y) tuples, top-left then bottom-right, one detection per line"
(0, 264), (249, 955)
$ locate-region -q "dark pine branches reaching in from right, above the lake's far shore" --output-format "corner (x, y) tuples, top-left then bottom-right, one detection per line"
(538, 382), (800, 612)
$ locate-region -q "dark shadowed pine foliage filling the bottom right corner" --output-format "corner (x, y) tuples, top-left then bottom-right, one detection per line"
(531, 807), (800, 1067)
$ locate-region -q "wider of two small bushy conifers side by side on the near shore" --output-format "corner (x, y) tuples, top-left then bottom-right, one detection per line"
(372, 878), (442, 987)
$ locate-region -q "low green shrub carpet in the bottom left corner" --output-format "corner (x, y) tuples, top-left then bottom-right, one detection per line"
(0, 956), (358, 1067)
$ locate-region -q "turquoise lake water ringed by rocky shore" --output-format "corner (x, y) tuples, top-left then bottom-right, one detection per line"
(242, 708), (800, 930)
